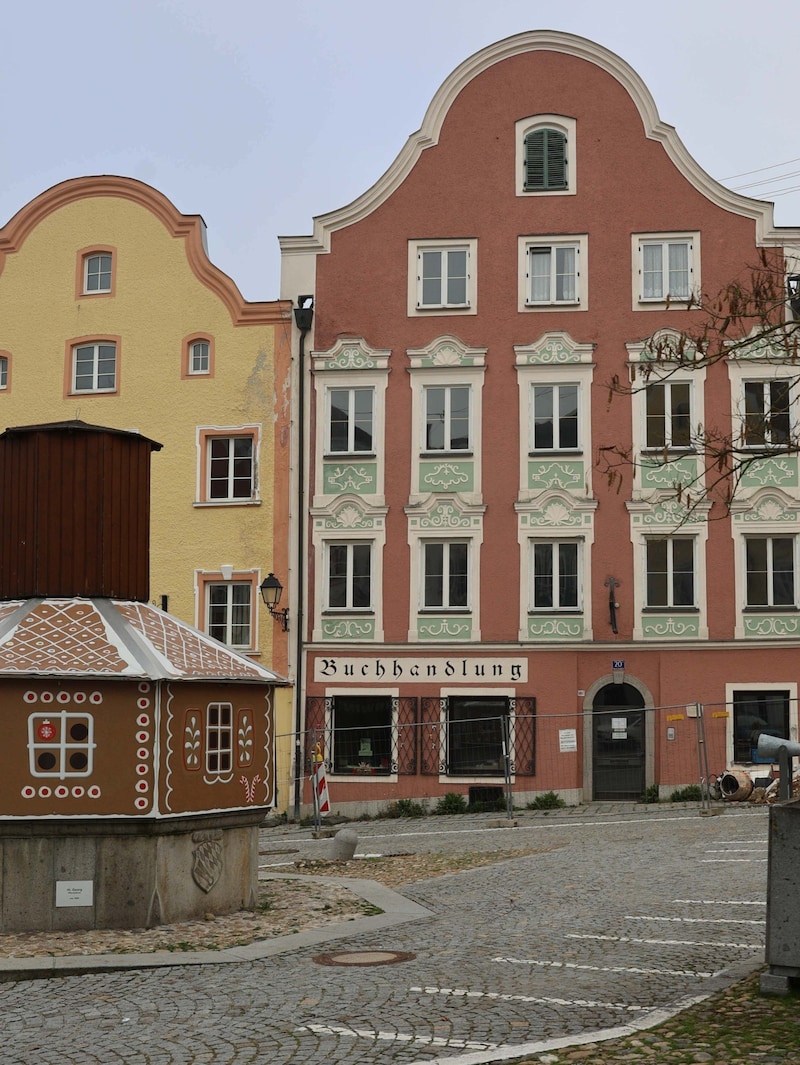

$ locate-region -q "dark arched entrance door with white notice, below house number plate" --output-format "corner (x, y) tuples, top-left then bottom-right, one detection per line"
(591, 683), (647, 802)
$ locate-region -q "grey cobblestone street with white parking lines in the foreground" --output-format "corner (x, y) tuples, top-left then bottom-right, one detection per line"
(0, 805), (768, 1065)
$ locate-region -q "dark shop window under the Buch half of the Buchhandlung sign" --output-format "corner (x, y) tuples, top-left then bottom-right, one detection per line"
(332, 695), (392, 775)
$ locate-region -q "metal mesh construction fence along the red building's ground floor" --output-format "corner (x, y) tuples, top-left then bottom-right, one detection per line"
(275, 698), (788, 812)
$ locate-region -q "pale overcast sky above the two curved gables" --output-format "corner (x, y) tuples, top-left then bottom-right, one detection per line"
(0, 0), (800, 299)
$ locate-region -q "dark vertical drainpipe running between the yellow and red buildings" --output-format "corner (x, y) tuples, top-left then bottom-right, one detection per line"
(294, 296), (314, 821)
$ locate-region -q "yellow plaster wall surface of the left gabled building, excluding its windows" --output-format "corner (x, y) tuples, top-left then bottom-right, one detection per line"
(0, 178), (291, 800)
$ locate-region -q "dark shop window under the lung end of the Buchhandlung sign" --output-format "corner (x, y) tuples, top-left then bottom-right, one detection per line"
(447, 695), (509, 776)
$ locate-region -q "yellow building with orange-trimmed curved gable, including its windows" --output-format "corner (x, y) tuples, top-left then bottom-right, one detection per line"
(0, 177), (292, 805)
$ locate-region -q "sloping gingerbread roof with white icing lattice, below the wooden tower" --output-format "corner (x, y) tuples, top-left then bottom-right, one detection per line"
(0, 599), (287, 684)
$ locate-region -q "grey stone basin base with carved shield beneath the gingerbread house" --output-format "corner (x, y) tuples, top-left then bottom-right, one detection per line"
(0, 808), (266, 933)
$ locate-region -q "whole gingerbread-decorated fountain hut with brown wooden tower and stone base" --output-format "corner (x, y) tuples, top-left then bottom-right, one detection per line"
(0, 422), (285, 932)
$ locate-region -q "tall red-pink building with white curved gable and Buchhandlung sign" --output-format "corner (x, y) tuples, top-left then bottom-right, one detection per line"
(281, 32), (800, 812)
